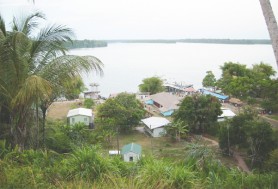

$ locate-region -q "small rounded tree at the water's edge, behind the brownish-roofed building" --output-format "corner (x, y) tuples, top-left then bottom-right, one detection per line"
(139, 77), (164, 94)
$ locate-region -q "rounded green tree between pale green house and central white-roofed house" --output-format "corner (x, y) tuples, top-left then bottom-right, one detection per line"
(96, 93), (145, 132)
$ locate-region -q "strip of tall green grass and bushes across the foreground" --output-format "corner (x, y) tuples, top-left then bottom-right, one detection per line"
(0, 144), (278, 189)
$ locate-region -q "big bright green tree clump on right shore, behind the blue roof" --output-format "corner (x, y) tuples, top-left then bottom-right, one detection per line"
(217, 62), (277, 104)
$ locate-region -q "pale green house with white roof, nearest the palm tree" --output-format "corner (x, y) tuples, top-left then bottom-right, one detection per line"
(67, 108), (94, 128)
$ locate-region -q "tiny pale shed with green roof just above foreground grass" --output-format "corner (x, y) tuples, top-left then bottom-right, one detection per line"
(121, 143), (142, 162)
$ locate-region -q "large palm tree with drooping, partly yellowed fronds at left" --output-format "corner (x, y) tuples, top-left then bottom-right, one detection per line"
(0, 13), (103, 149)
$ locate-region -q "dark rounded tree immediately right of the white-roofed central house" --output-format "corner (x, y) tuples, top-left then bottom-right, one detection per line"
(174, 95), (222, 133)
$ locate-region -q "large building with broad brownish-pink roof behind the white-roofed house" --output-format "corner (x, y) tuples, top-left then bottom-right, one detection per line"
(145, 92), (182, 116)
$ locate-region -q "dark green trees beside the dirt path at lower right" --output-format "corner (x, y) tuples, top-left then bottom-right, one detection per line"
(219, 110), (278, 169)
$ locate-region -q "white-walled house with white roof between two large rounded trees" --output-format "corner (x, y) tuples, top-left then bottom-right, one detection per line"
(141, 117), (170, 137)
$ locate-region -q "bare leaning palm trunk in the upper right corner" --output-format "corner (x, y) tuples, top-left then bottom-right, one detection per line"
(260, 0), (278, 67)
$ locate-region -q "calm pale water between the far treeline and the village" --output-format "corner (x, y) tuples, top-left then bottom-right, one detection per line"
(70, 43), (277, 97)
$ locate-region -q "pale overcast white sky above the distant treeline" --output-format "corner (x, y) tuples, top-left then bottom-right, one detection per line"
(0, 0), (278, 40)
